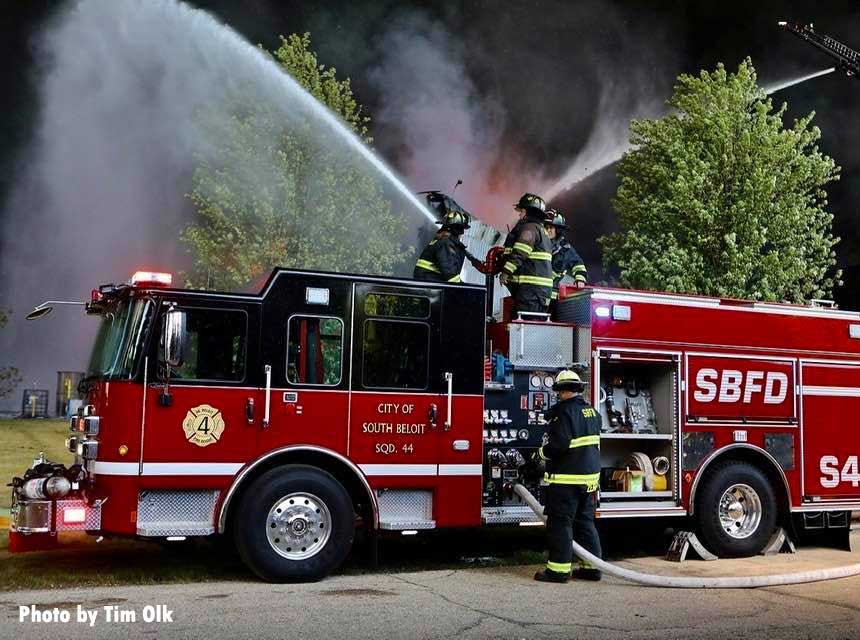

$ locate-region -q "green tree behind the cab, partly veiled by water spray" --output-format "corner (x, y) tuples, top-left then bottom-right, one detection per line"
(182, 33), (412, 289)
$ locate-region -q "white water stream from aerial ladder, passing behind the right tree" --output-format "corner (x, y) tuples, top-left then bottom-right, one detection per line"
(544, 67), (836, 199)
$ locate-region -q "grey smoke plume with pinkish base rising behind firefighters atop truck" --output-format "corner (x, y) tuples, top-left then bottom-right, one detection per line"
(368, 13), (531, 230)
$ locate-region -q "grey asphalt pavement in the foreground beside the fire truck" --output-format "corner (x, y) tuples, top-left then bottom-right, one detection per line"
(0, 533), (860, 640)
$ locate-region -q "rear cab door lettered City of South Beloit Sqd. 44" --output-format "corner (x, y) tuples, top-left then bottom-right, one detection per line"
(349, 283), (446, 480)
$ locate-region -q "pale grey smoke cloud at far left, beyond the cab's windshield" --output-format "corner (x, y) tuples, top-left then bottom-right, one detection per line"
(0, 2), (203, 407)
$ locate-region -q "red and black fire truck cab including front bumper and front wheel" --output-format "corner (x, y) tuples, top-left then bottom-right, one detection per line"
(13, 270), (485, 579)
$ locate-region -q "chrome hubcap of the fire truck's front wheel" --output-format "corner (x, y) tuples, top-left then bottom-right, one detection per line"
(266, 493), (331, 560)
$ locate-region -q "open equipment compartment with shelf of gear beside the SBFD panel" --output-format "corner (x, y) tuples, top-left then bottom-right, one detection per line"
(593, 352), (680, 507)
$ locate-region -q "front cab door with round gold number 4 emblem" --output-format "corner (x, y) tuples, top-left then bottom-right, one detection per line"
(141, 297), (262, 488)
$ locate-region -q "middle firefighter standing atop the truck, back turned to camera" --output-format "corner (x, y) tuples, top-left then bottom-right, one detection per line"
(499, 193), (552, 317)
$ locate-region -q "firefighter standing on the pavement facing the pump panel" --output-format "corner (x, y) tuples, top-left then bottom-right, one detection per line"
(535, 370), (601, 582)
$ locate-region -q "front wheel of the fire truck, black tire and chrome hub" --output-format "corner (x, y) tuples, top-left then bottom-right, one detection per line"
(233, 465), (355, 582)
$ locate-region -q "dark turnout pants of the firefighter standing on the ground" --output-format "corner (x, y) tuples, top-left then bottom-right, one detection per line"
(545, 484), (603, 573)
